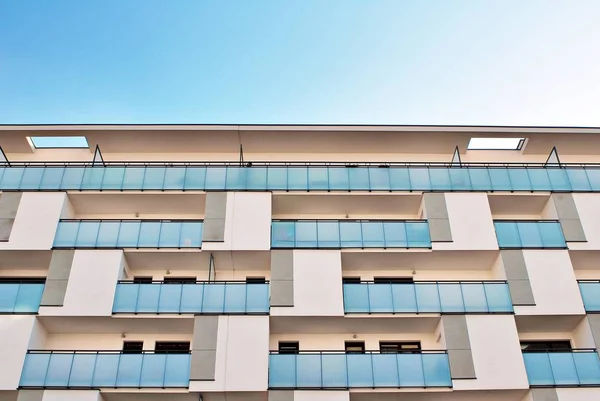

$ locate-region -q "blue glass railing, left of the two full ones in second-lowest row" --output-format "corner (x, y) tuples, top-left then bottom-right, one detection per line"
(113, 281), (269, 314)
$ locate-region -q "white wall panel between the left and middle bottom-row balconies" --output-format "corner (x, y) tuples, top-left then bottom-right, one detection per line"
(190, 316), (269, 392)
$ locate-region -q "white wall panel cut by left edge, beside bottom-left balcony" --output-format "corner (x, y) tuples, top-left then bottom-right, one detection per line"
(0, 315), (36, 390)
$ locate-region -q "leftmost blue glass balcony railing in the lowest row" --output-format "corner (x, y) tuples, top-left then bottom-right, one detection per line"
(19, 351), (190, 388)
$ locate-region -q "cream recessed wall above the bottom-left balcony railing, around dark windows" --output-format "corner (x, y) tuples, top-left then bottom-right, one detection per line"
(44, 332), (192, 351)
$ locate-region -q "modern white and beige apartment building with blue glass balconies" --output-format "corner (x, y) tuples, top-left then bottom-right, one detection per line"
(0, 125), (600, 401)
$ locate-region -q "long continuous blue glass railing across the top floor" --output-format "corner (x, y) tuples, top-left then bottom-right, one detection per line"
(0, 162), (600, 192)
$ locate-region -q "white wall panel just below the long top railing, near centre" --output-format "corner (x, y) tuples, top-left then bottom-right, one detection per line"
(202, 192), (272, 251)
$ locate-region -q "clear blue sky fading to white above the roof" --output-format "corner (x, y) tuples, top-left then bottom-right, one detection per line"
(0, 0), (600, 126)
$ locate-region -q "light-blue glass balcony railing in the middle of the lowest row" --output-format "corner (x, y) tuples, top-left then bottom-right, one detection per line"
(269, 351), (452, 389)
